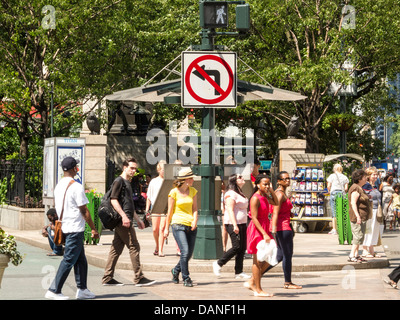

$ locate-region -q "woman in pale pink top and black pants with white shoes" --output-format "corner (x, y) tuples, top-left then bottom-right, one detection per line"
(213, 174), (250, 279)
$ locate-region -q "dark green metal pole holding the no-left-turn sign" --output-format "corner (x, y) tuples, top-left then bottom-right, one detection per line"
(193, 0), (249, 260)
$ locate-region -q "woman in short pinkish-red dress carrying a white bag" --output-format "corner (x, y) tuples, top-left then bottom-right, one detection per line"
(244, 175), (278, 297)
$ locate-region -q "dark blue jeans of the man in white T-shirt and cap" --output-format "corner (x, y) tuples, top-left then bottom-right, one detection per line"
(49, 232), (88, 293)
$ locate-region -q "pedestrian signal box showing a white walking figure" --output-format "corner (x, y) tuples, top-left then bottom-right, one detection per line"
(200, 1), (228, 29)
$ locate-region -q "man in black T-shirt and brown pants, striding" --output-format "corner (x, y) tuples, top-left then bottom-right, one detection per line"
(102, 158), (155, 286)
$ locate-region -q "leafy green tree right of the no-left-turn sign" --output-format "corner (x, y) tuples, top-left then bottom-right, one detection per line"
(222, 0), (400, 152)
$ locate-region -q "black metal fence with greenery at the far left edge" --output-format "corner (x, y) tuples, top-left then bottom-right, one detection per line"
(0, 160), (43, 208)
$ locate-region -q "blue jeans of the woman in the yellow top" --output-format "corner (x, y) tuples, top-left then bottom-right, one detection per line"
(171, 224), (197, 280)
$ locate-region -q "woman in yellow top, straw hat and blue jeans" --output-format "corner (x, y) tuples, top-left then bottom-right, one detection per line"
(164, 168), (197, 287)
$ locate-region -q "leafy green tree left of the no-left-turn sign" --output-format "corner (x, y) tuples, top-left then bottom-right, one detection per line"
(0, 0), (200, 157)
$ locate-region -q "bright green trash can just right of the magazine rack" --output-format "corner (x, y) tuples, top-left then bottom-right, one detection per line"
(335, 193), (353, 244)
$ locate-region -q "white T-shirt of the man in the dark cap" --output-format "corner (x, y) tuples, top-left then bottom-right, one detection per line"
(54, 177), (89, 233)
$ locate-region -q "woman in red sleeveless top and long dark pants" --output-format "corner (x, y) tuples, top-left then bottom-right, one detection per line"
(267, 171), (302, 289)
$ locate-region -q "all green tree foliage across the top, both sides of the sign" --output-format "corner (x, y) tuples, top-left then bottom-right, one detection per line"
(0, 0), (400, 158)
